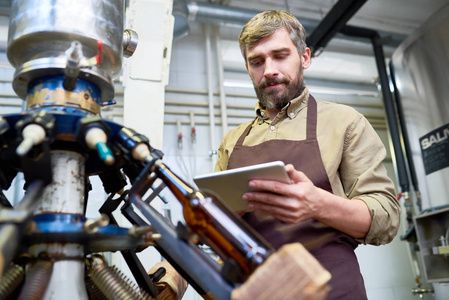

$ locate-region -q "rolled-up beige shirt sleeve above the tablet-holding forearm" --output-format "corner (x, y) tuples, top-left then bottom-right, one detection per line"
(340, 113), (401, 245)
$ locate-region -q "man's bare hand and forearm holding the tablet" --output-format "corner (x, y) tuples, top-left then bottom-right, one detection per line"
(243, 165), (372, 238)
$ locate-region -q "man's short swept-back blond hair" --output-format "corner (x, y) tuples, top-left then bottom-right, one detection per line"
(239, 10), (306, 61)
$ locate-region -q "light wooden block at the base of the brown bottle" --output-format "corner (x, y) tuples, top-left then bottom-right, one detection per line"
(231, 243), (331, 300)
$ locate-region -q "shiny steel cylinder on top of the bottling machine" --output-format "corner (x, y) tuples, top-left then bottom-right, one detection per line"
(7, 0), (124, 101)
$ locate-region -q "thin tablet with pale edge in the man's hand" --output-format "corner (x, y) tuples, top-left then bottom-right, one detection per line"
(193, 161), (291, 210)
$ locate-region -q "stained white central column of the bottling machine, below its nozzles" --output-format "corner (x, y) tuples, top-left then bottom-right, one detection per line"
(30, 150), (88, 299)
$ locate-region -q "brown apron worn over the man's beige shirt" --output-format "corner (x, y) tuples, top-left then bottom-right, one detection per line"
(228, 95), (367, 300)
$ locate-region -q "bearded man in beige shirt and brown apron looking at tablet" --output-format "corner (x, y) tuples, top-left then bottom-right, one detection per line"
(215, 10), (400, 300)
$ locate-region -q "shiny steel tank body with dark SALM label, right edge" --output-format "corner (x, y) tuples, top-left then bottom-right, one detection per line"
(392, 6), (449, 209)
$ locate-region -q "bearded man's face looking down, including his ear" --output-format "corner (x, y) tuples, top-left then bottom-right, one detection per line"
(246, 28), (310, 109)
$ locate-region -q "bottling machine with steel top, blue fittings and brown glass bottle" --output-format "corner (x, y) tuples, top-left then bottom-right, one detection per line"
(0, 0), (329, 299)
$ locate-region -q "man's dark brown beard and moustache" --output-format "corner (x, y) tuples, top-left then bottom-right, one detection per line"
(254, 66), (304, 109)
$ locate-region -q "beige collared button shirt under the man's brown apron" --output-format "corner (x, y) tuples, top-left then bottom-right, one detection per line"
(215, 88), (401, 245)
